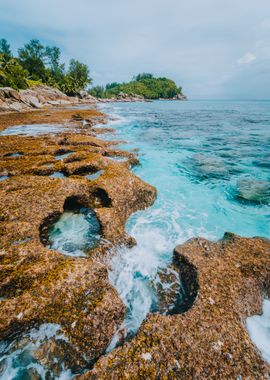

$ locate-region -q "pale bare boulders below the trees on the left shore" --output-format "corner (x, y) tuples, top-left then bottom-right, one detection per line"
(0, 85), (96, 111)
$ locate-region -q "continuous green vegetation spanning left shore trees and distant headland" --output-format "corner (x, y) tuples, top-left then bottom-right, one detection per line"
(0, 38), (182, 99)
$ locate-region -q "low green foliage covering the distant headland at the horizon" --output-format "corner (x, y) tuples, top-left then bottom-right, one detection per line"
(90, 73), (182, 99)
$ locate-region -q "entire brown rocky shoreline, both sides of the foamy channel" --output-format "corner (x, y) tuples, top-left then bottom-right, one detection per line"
(0, 99), (270, 379)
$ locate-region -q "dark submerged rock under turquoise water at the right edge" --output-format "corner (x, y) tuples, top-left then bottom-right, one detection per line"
(236, 179), (270, 204)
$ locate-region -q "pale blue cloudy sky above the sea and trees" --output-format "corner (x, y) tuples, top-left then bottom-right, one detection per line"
(0, 0), (270, 99)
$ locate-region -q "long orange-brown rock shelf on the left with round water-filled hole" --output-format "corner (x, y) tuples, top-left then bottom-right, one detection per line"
(0, 109), (156, 378)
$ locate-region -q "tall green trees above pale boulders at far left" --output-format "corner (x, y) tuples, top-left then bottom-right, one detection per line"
(0, 39), (92, 95)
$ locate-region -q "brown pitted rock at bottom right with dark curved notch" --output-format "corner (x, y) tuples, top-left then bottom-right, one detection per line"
(80, 234), (270, 380)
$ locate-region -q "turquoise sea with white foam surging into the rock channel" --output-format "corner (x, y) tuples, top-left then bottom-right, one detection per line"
(99, 101), (270, 351)
